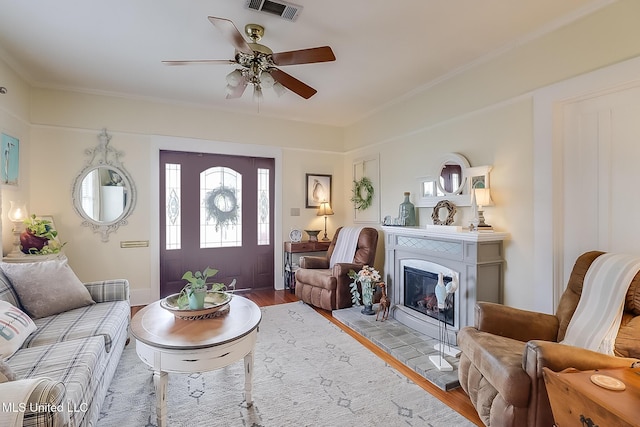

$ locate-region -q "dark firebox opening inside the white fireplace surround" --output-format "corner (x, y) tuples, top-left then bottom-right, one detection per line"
(404, 266), (455, 326)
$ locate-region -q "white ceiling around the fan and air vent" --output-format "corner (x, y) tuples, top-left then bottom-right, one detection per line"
(0, 0), (611, 126)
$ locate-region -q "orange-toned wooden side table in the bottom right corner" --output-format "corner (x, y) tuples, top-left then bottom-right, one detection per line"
(543, 368), (640, 427)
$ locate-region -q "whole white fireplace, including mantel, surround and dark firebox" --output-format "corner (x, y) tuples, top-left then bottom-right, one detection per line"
(382, 226), (507, 345)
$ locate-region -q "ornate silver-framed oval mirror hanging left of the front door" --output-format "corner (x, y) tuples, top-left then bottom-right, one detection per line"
(72, 130), (136, 242)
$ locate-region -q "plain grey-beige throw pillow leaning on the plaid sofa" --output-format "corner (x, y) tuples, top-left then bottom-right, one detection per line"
(0, 260), (95, 319)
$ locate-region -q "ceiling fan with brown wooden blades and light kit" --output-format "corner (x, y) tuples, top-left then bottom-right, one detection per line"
(162, 16), (336, 100)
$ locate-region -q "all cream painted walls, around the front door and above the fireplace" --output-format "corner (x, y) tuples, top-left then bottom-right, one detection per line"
(0, 0), (640, 308)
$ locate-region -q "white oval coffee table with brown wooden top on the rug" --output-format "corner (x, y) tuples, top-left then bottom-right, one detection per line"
(131, 295), (262, 427)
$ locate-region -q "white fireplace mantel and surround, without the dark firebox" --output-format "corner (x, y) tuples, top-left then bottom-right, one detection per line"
(382, 226), (509, 343)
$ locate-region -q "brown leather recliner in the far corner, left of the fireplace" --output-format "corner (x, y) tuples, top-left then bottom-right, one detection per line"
(296, 227), (378, 310)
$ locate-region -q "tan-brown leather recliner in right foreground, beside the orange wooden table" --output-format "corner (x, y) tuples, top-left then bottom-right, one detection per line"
(458, 251), (640, 427)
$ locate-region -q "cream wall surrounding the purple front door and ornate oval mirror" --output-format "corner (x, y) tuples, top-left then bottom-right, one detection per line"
(23, 89), (345, 303)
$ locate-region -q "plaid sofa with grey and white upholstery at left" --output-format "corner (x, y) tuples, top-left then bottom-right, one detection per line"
(0, 270), (131, 427)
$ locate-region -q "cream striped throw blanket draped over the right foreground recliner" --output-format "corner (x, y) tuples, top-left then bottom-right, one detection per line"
(562, 253), (640, 355)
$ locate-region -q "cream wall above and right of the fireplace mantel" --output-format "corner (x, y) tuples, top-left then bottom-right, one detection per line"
(345, 0), (640, 309)
